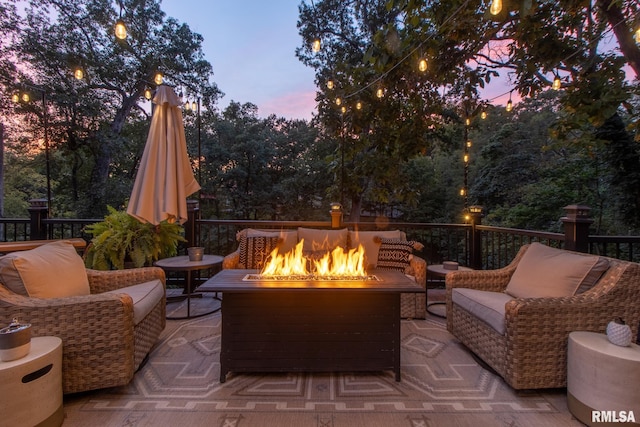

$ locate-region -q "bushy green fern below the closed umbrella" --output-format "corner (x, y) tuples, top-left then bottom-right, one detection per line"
(85, 206), (186, 270)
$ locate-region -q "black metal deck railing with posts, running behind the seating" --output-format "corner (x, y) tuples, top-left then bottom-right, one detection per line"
(0, 202), (640, 269)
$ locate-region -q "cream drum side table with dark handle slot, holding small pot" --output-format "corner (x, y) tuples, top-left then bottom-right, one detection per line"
(0, 337), (64, 427)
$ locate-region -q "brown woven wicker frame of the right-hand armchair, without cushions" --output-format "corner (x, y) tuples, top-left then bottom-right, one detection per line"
(446, 246), (640, 389)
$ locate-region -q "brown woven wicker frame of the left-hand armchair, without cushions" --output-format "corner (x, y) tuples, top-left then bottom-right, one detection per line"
(0, 267), (166, 393)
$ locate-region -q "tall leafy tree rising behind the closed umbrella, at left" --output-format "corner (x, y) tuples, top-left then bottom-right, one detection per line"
(0, 0), (220, 215)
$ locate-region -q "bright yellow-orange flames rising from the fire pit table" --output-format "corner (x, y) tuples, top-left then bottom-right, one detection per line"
(260, 240), (367, 278)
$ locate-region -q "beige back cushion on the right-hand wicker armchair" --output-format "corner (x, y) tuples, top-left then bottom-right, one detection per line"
(506, 242), (609, 298)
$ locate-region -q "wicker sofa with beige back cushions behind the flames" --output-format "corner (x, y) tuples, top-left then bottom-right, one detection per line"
(222, 227), (427, 319)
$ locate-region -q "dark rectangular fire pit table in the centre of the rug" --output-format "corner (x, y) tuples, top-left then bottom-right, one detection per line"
(197, 270), (424, 382)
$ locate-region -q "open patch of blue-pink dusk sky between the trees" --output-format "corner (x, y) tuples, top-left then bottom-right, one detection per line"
(161, 0), (316, 119)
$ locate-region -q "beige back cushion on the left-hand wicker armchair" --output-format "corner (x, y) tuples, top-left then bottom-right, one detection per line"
(0, 240), (90, 298)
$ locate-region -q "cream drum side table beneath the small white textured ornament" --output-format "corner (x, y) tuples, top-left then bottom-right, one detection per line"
(567, 332), (640, 426)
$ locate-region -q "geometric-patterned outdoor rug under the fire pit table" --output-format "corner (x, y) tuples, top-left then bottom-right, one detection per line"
(65, 298), (579, 427)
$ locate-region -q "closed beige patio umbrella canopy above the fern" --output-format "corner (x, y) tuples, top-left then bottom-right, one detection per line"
(127, 85), (200, 225)
